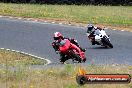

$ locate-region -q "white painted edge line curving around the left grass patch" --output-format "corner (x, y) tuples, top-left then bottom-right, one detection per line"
(0, 48), (51, 65)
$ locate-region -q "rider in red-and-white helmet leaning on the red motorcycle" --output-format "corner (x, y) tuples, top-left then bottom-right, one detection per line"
(52, 32), (85, 63)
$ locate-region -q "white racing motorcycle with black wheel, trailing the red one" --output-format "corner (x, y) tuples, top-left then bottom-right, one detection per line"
(87, 30), (113, 48)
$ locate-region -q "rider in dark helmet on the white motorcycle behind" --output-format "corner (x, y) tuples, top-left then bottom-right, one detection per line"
(87, 24), (103, 45)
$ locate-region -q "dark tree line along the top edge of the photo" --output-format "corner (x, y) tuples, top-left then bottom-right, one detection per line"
(0, 0), (132, 5)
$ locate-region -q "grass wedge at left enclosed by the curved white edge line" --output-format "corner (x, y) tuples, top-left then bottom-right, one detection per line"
(0, 49), (46, 66)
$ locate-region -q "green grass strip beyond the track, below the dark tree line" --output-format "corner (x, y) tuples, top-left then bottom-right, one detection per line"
(0, 3), (132, 26)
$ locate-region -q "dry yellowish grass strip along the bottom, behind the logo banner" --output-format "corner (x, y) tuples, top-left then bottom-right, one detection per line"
(0, 65), (132, 88)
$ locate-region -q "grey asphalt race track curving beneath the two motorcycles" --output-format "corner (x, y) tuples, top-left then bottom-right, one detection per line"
(0, 18), (132, 65)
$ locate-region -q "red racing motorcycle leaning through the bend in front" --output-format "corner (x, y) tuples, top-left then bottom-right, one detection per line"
(59, 39), (86, 63)
